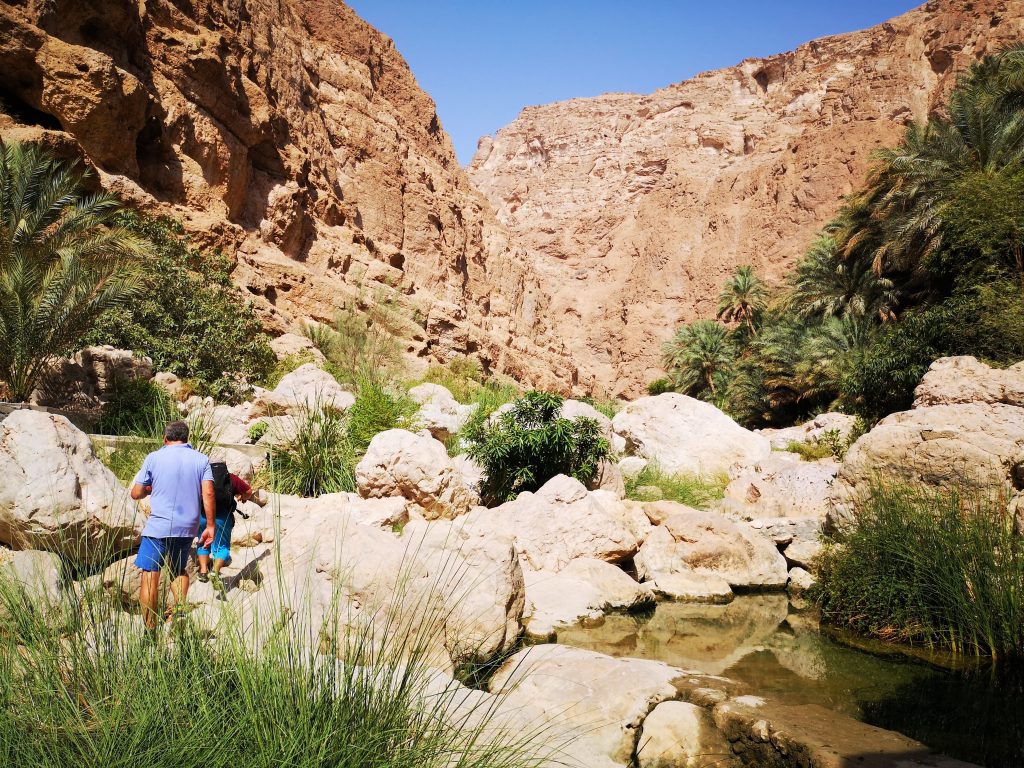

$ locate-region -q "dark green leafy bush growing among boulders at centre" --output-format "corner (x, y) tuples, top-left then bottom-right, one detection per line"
(468, 392), (611, 504)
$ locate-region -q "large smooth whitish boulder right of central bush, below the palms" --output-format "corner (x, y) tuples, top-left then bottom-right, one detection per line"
(611, 399), (771, 475)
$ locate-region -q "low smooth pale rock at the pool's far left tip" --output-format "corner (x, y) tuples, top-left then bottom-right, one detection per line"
(523, 557), (654, 638)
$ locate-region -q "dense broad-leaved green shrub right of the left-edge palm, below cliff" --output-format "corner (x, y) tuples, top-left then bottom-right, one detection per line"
(86, 212), (274, 400)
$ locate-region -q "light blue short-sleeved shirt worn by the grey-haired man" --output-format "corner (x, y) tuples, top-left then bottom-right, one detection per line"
(135, 444), (213, 539)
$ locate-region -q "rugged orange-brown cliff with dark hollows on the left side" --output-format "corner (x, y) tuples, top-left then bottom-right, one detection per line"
(0, 0), (573, 388)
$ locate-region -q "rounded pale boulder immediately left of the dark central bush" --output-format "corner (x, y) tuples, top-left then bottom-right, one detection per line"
(355, 429), (478, 520)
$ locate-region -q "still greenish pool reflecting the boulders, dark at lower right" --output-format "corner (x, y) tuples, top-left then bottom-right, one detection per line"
(558, 594), (1024, 768)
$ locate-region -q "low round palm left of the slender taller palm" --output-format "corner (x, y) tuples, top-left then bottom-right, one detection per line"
(664, 321), (734, 396)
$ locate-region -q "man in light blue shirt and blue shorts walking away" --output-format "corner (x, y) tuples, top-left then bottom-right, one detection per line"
(131, 421), (217, 629)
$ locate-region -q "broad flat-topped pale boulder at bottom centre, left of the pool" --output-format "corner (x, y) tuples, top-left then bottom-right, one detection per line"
(490, 645), (684, 768)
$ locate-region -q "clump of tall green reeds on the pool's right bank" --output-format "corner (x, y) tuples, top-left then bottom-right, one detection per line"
(811, 485), (1024, 657)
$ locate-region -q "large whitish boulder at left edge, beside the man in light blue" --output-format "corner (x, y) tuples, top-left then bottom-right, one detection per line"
(0, 410), (144, 565)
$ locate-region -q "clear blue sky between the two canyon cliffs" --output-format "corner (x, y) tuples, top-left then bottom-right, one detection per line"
(348, 0), (923, 165)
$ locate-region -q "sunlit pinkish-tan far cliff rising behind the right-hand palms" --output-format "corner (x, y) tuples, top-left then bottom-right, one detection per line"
(469, 0), (1024, 393)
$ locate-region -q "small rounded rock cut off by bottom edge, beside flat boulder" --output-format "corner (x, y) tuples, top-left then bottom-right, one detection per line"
(637, 701), (741, 768)
